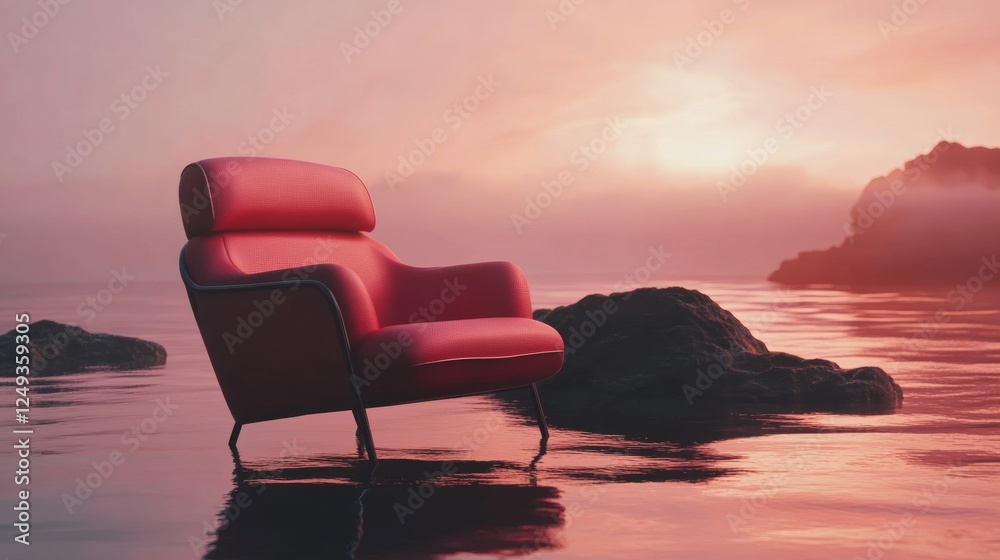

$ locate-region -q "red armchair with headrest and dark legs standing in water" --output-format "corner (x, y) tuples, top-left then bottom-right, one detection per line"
(180, 158), (563, 461)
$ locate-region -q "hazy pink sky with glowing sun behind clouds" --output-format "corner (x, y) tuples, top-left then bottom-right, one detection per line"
(0, 0), (1000, 283)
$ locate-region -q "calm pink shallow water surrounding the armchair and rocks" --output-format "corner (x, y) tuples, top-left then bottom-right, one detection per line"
(0, 281), (1000, 559)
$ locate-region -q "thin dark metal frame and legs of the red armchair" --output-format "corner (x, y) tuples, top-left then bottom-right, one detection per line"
(180, 249), (549, 463)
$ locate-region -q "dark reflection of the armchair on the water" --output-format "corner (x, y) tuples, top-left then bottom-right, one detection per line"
(201, 452), (566, 560)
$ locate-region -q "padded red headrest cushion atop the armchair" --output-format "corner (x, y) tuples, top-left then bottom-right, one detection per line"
(180, 157), (375, 239)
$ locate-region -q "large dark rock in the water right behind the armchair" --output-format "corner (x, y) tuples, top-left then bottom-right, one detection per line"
(503, 288), (903, 432)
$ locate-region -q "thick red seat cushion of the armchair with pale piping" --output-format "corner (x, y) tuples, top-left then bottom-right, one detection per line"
(352, 317), (563, 406)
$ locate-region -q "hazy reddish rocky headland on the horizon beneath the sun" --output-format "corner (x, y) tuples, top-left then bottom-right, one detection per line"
(768, 142), (1000, 286)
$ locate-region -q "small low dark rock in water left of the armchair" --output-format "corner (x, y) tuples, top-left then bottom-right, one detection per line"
(0, 320), (167, 375)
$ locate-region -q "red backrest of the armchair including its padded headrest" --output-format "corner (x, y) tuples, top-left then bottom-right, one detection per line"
(180, 158), (400, 324)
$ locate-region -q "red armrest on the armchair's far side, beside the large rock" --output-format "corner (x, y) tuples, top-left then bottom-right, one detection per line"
(393, 262), (531, 324)
